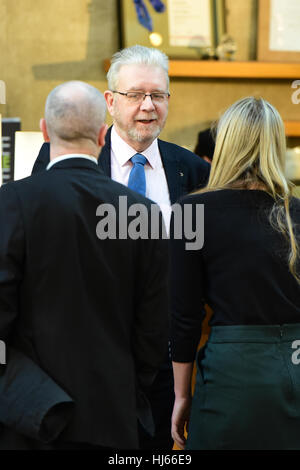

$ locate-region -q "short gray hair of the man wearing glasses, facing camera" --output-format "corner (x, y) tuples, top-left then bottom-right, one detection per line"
(107, 45), (170, 91)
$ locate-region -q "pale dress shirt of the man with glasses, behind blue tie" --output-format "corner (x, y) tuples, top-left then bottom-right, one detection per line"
(110, 127), (171, 228)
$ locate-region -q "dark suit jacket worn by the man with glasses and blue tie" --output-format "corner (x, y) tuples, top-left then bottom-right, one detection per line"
(32, 128), (210, 204)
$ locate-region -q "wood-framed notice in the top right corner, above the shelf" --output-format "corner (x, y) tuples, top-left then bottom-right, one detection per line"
(257, 0), (300, 62)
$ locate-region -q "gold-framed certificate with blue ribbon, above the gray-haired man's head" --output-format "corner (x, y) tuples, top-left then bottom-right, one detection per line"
(118, 0), (225, 59)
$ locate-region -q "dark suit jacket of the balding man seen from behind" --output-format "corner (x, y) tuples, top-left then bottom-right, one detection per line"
(0, 158), (168, 449)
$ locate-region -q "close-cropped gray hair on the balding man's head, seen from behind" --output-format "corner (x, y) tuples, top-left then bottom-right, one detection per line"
(45, 80), (106, 143)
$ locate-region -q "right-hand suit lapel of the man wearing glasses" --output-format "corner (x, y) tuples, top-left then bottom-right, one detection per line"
(158, 139), (182, 204)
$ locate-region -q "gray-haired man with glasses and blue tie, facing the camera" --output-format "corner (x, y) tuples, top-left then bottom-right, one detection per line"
(33, 45), (210, 450)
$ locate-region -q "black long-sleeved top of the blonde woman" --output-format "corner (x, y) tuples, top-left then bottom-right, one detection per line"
(170, 189), (300, 362)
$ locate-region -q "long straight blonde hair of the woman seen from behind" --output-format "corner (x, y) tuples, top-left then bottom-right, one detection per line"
(200, 97), (300, 283)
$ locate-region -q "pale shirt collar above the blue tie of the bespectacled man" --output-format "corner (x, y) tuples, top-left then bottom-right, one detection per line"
(111, 126), (160, 169)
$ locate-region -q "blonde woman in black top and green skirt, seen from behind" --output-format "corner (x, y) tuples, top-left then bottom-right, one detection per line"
(171, 97), (300, 449)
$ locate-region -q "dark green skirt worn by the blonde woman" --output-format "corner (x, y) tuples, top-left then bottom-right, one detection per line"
(186, 323), (300, 450)
